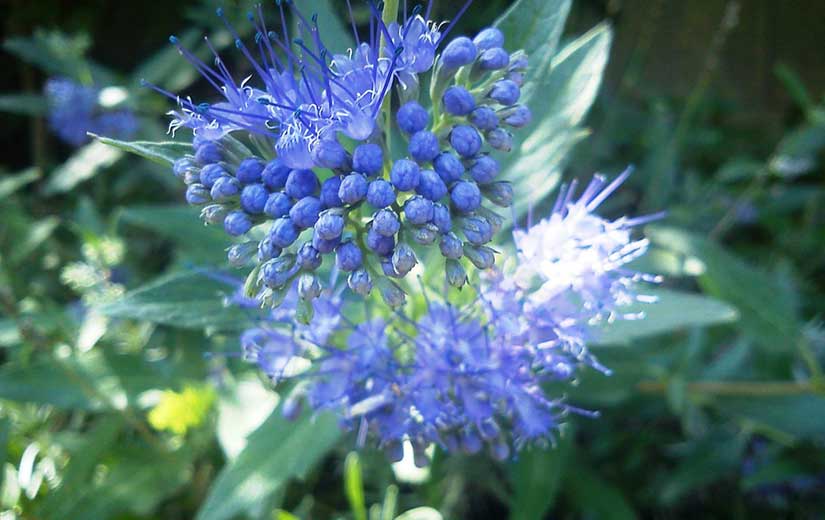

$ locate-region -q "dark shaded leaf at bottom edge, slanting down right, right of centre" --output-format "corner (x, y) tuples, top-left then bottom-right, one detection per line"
(564, 461), (637, 520)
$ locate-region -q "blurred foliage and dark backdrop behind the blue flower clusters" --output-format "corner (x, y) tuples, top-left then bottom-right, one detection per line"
(0, 0), (825, 520)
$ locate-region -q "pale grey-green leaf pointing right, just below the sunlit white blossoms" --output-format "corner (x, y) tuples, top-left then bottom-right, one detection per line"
(594, 287), (737, 345)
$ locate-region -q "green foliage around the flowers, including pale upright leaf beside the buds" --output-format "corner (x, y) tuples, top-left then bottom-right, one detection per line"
(0, 0), (825, 520)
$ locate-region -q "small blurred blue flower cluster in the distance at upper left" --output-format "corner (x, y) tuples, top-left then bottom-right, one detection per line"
(44, 78), (137, 146)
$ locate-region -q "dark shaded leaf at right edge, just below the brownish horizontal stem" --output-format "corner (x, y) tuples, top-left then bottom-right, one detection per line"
(711, 394), (825, 441)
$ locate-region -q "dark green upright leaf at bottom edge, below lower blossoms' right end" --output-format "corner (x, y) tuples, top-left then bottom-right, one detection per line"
(509, 431), (572, 520)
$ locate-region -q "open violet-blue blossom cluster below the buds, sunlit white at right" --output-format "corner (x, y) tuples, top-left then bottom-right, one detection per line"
(242, 172), (658, 462)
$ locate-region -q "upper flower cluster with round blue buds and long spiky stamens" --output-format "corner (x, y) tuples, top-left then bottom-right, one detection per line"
(153, 2), (530, 308)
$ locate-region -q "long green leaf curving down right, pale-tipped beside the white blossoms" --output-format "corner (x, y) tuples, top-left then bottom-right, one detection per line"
(646, 226), (799, 351)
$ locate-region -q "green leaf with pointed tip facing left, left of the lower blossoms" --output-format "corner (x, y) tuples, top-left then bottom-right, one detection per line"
(97, 271), (251, 330)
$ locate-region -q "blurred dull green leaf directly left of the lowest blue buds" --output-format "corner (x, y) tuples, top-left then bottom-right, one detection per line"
(120, 206), (230, 265)
